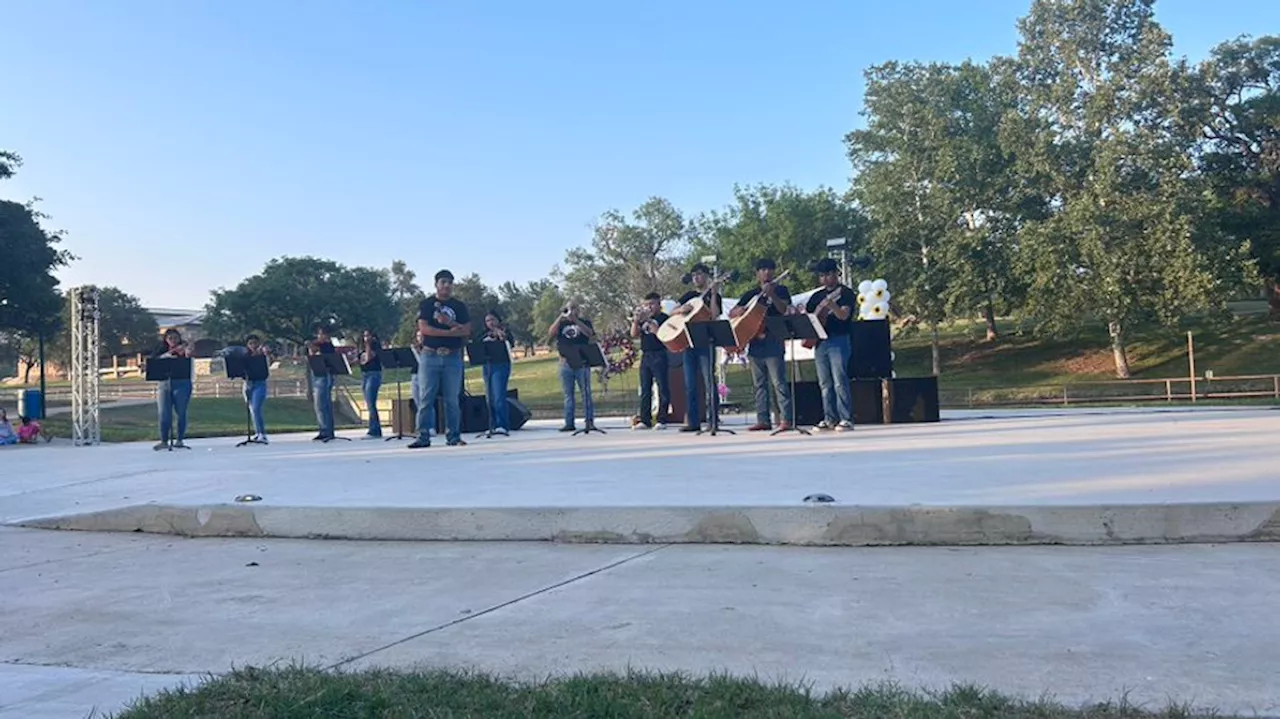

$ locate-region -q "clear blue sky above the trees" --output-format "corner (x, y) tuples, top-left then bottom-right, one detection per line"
(0, 0), (1280, 307)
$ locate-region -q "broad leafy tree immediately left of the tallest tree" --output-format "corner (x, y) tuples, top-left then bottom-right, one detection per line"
(845, 63), (1021, 374)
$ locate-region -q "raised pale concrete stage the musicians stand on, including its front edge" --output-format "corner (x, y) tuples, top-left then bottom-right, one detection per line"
(0, 406), (1280, 545)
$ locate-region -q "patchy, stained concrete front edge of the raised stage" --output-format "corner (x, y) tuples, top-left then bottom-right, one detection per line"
(12, 502), (1280, 546)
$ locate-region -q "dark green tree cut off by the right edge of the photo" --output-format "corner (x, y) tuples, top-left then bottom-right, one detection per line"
(1192, 36), (1280, 319)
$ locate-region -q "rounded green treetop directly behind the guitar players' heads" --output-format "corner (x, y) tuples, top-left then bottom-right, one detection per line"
(696, 184), (867, 292)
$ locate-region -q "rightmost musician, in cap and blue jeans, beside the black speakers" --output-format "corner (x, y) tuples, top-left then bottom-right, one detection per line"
(805, 257), (858, 431)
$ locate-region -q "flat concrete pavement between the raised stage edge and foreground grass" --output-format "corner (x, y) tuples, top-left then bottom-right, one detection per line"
(0, 528), (1280, 719)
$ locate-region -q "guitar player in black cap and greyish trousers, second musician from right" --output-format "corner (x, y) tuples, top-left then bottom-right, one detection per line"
(730, 257), (791, 432)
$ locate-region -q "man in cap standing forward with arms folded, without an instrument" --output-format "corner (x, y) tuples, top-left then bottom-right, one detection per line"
(408, 270), (471, 449)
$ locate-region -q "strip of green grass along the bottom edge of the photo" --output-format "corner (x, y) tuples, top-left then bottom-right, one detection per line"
(116, 668), (1228, 719)
